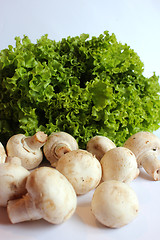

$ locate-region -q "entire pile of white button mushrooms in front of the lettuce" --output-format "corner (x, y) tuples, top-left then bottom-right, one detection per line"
(0, 132), (160, 228)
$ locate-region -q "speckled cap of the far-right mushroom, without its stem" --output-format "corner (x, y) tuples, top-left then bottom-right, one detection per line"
(124, 132), (160, 164)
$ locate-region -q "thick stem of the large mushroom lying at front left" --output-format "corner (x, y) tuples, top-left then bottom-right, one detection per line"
(7, 194), (42, 223)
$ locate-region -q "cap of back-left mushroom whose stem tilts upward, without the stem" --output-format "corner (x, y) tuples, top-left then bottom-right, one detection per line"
(6, 134), (43, 169)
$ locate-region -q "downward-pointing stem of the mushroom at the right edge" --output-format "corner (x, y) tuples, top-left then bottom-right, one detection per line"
(138, 150), (160, 181)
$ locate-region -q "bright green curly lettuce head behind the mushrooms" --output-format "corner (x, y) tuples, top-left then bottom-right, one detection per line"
(0, 31), (160, 148)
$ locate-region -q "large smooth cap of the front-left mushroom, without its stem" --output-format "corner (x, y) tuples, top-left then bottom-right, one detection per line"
(26, 167), (77, 224)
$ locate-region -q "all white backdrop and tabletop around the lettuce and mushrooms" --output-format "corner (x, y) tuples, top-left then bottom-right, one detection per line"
(0, 0), (160, 240)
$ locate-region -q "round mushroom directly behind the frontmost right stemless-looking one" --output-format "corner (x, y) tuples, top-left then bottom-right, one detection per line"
(100, 147), (139, 183)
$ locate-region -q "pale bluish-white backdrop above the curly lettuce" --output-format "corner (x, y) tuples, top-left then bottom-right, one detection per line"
(0, 0), (160, 76)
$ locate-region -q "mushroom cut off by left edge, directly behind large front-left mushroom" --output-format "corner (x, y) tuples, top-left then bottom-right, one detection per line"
(0, 158), (30, 207)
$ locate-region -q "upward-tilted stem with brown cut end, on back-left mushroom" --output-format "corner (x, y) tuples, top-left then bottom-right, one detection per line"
(23, 131), (47, 150)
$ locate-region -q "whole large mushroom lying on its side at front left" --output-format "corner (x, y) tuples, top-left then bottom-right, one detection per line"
(7, 167), (77, 224)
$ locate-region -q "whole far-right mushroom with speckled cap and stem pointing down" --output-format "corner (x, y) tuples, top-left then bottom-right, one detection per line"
(124, 132), (160, 181)
